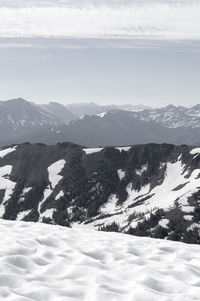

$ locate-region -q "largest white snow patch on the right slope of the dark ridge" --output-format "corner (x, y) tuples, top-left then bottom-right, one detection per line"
(87, 157), (200, 230)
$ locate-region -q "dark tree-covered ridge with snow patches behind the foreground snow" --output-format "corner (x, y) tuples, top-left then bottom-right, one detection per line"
(0, 143), (200, 243)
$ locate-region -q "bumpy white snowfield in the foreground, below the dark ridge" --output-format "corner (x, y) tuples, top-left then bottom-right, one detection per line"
(0, 220), (200, 301)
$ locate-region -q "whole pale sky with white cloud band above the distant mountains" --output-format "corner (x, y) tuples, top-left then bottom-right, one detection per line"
(0, 0), (200, 106)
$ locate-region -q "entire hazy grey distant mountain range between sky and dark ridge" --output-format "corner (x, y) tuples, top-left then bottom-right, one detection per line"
(0, 98), (200, 147)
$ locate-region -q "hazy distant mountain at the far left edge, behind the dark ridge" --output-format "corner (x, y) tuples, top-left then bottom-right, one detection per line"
(0, 98), (76, 146)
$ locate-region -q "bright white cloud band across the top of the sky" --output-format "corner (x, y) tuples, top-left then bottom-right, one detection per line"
(0, 0), (200, 41)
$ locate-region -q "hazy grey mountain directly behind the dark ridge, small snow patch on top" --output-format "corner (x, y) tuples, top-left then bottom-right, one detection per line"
(42, 110), (200, 147)
